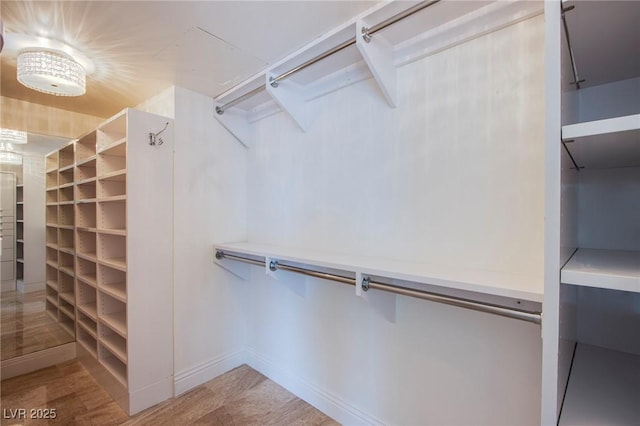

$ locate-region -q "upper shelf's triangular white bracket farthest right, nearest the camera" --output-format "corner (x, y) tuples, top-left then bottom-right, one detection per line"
(356, 21), (398, 108)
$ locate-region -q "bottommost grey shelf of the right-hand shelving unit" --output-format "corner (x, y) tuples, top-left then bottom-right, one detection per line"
(559, 344), (640, 425)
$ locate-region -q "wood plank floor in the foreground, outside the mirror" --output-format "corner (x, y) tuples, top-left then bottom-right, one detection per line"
(0, 361), (337, 426)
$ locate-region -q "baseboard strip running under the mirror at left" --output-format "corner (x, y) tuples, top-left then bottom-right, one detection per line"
(0, 342), (76, 380)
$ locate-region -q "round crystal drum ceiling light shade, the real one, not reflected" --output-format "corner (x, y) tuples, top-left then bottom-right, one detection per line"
(18, 50), (86, 96)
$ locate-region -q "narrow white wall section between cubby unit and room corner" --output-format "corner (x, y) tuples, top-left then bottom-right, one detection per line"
(174, 88), (247, 393)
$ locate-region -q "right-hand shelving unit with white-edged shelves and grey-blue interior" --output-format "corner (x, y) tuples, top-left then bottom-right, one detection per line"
(559, 2), (640, 425)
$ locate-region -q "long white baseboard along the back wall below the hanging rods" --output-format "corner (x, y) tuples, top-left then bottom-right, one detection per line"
(246, 347), (385, 425)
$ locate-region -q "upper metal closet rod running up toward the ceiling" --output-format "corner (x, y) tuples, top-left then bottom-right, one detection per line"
(216, 0), (440, 115)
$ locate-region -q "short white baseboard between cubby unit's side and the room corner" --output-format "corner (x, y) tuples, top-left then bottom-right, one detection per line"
(174, 350), (246, 396)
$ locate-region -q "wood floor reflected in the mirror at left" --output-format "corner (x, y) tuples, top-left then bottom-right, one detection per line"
(0, 290), (75, 360)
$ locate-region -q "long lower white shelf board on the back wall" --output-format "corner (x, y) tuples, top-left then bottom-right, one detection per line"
(214, 242), (543, 302)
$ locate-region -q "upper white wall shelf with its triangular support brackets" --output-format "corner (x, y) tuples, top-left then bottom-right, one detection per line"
(213, 1), (543, 147)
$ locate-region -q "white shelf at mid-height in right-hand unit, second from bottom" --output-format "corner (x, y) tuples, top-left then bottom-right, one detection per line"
(561, 249), (640, 293)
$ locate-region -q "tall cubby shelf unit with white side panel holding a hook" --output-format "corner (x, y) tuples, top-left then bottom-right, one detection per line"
(48, 109), (173, 414)
